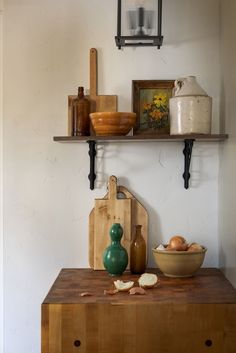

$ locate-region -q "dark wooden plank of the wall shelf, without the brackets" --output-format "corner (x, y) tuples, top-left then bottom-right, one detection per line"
(53, 134), (229, 143)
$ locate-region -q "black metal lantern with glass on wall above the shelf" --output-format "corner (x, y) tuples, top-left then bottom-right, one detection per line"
(115, 0), (163, 49)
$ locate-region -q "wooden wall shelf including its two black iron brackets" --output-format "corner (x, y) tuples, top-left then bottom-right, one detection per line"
(53, 134), (228, 190)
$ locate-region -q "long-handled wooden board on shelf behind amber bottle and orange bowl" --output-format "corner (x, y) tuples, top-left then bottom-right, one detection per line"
(68, 48), (118, 136)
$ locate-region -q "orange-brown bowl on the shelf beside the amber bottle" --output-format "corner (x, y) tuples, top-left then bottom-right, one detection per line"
(90, 112), (136, 136)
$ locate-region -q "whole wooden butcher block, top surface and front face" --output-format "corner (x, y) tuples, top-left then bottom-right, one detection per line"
(41, 268), (236, 353)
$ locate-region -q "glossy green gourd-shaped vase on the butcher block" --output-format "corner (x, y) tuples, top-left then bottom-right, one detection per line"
(103, 223), (128, 276)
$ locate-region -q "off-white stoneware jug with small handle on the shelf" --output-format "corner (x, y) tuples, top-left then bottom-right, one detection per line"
(169, 76), (212, 135)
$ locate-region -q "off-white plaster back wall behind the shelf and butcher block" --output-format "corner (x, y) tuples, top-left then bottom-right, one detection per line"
(3, 0), (220, 353)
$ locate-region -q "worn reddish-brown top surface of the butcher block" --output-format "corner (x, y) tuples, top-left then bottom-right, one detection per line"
(43, 268), (236, 304)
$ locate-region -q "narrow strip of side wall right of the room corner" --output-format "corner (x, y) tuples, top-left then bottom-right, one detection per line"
(219, 0), (236, 287)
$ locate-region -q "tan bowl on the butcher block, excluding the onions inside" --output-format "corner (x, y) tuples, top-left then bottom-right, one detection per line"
(152, 246), (207, 277)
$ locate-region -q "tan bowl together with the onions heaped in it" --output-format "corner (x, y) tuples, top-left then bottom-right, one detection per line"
(152, 236), (207, 277)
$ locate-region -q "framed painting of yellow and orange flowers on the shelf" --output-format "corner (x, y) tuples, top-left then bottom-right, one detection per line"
(132, 80), (174, 135)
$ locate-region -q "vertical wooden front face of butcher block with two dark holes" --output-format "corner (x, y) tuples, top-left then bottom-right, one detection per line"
(42, 303), (236, 353)
